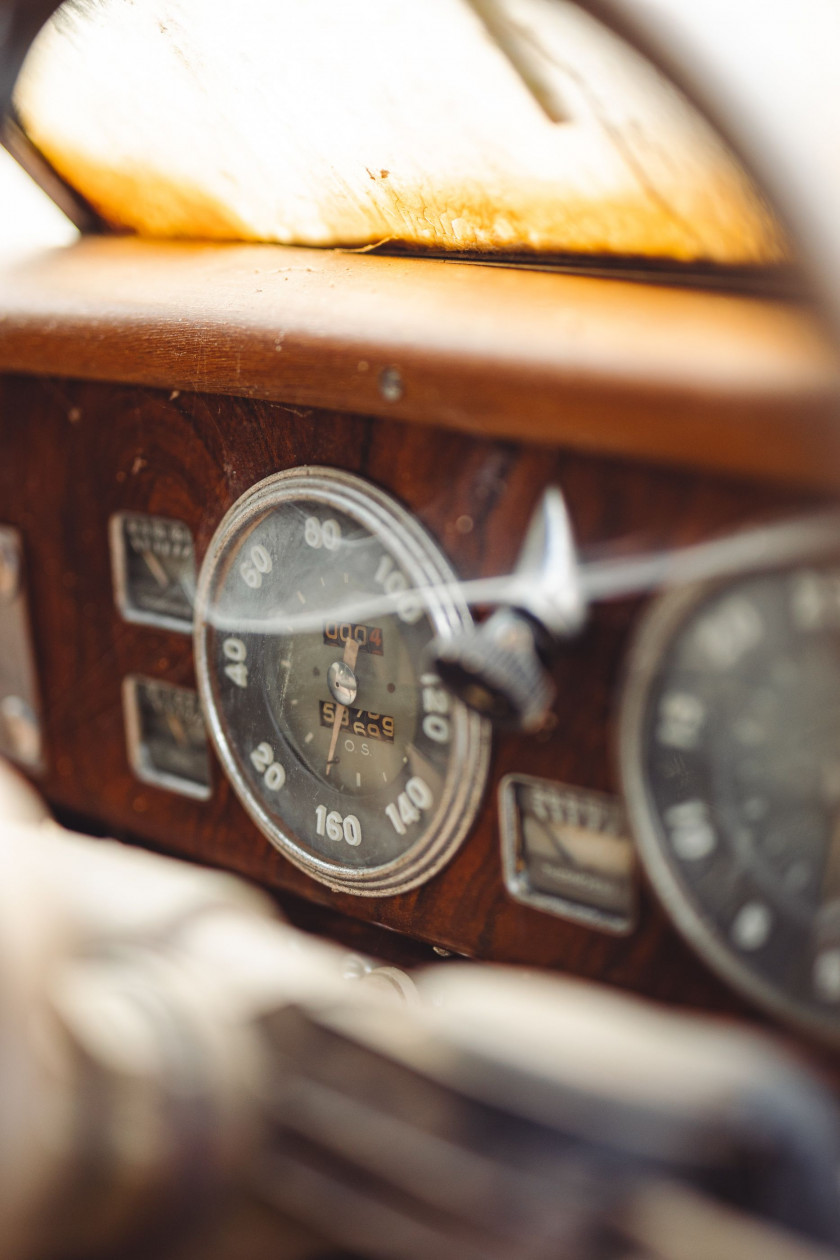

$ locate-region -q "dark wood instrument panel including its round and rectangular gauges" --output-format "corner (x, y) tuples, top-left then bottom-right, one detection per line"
(0, 377), (840, 1053)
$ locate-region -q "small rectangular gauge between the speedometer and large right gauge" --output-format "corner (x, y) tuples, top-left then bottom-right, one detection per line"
(499, 775), (636, 934)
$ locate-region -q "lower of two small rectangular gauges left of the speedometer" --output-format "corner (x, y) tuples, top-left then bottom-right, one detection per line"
(122, 677), (210, 800)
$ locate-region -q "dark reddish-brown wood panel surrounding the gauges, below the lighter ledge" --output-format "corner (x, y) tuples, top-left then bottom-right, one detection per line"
(0, 377), (836, 1053)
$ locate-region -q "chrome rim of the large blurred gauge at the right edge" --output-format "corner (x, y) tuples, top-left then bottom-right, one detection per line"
(617, 563), (840, 1045)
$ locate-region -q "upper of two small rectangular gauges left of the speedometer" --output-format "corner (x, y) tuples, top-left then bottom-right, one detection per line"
(111, 512), (195, 634)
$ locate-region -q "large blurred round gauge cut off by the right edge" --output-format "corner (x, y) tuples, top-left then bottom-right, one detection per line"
(622, 567), (840, 1036)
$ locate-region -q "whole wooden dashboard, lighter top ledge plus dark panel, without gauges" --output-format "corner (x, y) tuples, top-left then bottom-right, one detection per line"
(0, 239), (840, 1053)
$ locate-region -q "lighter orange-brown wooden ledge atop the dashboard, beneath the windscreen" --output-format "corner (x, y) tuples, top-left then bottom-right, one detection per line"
(0, 238), (840, 489)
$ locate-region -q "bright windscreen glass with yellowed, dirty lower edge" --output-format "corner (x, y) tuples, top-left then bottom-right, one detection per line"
(15, 0), (786, 265)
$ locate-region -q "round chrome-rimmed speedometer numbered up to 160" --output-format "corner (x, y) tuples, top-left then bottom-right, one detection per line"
(196, 467), (487, 895)
